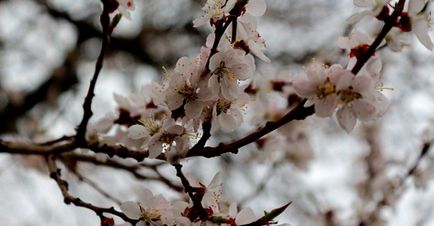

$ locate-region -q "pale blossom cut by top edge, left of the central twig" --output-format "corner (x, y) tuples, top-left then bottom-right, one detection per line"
(193, 0), (237, 27)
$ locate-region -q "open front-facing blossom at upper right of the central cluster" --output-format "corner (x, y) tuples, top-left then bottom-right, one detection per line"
(208, 49), (255, 100)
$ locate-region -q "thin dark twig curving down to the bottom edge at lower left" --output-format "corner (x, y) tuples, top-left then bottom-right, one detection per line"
(46, 155), (138, 225)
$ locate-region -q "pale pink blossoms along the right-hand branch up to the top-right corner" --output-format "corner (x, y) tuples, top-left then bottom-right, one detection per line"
(293, 0), (433, 132)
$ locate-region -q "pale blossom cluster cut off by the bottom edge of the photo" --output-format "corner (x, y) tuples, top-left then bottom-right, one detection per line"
(121, 172), (287, 226)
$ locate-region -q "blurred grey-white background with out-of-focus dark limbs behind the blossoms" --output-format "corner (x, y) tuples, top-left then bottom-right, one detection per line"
(0, 0), (434, 226)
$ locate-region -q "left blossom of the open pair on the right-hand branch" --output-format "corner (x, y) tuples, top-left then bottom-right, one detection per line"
(292, 63), (344, 117)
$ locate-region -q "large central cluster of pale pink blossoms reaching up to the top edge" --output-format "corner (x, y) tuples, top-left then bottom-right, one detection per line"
(88, 0), (269, 159)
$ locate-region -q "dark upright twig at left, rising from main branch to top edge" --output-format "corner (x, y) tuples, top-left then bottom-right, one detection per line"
(75, 1), (111, 146)
